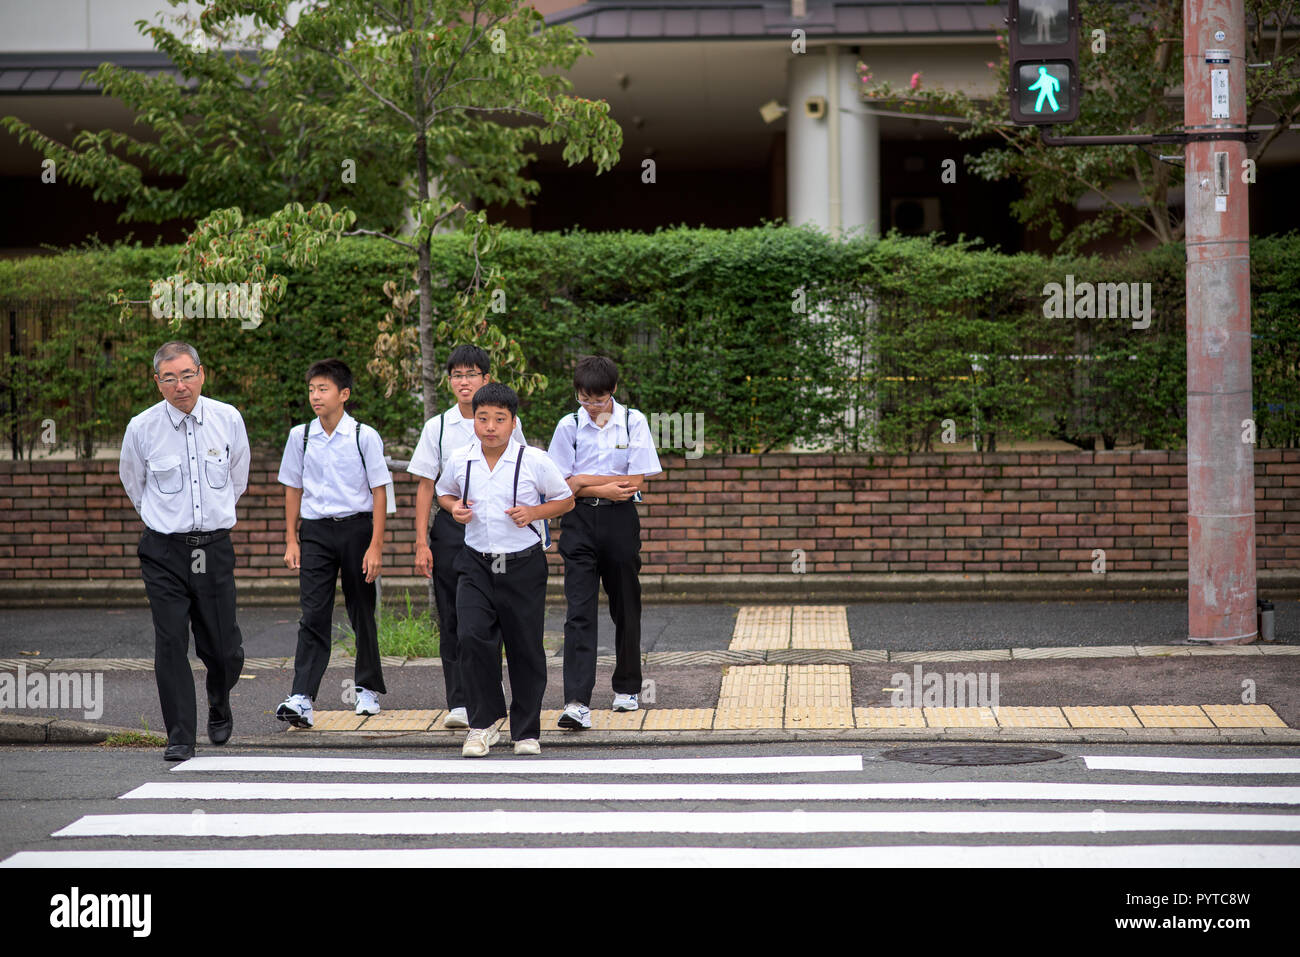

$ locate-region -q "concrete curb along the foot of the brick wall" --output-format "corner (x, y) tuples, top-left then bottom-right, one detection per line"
(0, 568), (1300, 609)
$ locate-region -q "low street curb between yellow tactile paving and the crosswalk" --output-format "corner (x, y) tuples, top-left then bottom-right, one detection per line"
(0, 715), (1300, 754)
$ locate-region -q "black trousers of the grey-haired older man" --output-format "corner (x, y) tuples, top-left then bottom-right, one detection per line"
(137, 529), (243, 746)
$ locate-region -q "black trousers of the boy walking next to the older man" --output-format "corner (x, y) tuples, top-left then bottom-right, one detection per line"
(293, 512), (387, 700)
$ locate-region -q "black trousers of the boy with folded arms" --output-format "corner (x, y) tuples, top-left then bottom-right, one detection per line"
(560, 501), (641, 706)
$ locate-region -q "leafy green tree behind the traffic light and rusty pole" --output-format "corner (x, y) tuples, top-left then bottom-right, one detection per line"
(859, 0), (1300, 252)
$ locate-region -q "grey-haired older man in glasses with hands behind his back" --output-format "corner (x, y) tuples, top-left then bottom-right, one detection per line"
(118, 342), (248, 761)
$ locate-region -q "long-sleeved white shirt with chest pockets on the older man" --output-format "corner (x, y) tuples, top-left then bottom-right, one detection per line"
(117, 395), (248, 534)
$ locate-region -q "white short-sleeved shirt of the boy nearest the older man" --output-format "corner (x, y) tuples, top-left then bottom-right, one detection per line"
(278, 412), (393, 519)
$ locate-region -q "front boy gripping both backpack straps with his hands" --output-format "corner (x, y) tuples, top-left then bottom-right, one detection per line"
(437, 382), (573, 758)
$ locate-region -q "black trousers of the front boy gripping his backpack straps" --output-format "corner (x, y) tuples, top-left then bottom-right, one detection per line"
(456, 545), (546, 741)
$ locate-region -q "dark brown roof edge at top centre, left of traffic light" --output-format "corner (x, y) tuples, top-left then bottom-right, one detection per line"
(546, 0), (1006, 40)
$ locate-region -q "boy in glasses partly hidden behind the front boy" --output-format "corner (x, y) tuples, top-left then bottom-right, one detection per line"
(407, 346), (524, 728)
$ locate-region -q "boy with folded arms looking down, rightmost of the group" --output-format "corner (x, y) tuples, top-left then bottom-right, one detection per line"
(547, 355), (662, 731)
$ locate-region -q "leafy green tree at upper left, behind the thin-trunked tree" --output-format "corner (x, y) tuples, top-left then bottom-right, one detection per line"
(0, 0), (408, 228)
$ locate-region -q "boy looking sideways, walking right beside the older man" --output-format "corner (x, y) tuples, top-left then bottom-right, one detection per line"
(276, 359), (393, 728)
